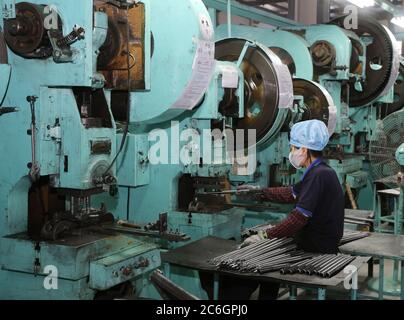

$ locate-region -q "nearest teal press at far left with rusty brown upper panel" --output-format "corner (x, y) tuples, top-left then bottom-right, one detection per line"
(0, 0), (169, 299)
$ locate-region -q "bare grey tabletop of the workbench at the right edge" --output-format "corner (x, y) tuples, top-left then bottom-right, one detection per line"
(339, 233), (404, 258)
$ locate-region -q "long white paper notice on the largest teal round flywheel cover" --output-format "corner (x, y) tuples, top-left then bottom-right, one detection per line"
(171, 40), (215, 110)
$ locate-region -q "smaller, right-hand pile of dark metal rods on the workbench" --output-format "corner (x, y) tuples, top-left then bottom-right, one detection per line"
(281, 254), (355, 278)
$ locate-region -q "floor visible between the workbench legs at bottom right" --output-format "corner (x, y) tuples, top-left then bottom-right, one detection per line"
(251, 260), (400, 300)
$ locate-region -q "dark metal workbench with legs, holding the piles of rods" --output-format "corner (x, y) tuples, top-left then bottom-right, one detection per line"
(161, 237), (369, 300)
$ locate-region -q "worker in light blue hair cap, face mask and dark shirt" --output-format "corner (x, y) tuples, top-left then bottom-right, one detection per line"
(243, 120), (345, 253)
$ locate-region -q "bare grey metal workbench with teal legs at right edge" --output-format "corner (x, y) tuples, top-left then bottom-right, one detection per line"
(340, 233), (404, 300)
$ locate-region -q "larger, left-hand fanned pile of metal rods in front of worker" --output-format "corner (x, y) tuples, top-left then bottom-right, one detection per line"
(209, 238), (315, 273)
